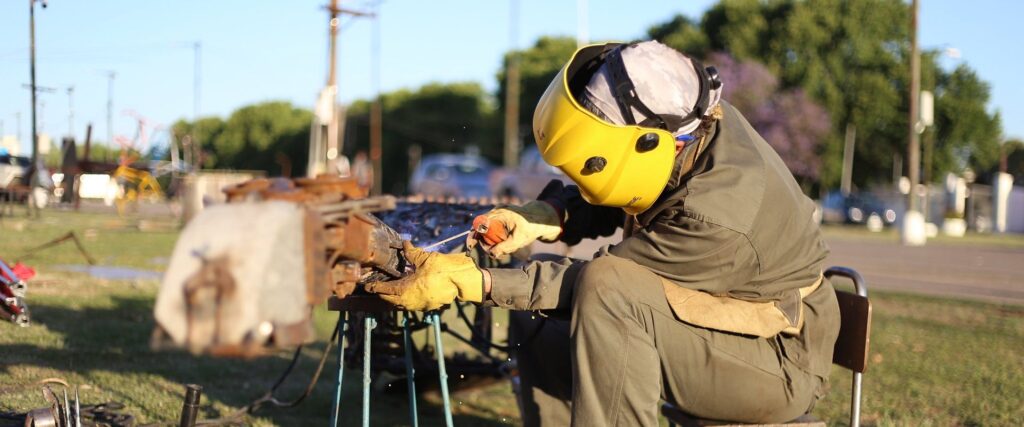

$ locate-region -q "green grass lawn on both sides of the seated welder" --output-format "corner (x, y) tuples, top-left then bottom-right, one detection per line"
(0, 212), (1024, 426)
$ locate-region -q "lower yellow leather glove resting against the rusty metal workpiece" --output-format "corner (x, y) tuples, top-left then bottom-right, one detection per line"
(367, 241), (483, 311)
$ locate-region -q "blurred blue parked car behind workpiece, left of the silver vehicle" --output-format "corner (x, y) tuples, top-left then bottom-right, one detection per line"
(409, 155), (495, 198)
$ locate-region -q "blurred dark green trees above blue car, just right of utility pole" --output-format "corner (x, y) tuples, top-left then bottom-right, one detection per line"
(345, 83), (502, 194)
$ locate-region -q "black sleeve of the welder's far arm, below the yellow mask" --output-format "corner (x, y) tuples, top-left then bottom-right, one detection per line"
(537, 179), (626, 246)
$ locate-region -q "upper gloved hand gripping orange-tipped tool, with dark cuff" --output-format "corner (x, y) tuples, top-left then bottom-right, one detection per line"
(466, 201), (562, 257)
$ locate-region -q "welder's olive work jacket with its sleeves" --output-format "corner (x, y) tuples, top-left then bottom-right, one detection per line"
(489, 102), (839, 378)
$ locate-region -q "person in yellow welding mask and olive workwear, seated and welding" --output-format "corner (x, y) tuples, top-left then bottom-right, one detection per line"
(372, 42), (840, 426)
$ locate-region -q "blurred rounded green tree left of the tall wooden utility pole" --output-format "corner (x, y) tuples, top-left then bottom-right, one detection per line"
(171, 101), (312, 175)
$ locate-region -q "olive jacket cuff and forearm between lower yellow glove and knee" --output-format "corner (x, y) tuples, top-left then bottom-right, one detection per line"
(487, 254), (586, 310)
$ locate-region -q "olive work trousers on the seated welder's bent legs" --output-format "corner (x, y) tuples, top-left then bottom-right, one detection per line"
(511, 256), (821, 427)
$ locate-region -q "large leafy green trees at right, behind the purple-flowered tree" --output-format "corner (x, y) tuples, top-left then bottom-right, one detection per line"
(648, 0), (1000, 187)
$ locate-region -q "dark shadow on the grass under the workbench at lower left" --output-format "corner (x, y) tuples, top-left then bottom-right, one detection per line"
(0, 295), (507, 426)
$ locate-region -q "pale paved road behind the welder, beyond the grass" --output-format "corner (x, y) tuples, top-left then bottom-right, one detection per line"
(534, 231), (1024, 305)
